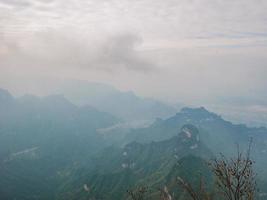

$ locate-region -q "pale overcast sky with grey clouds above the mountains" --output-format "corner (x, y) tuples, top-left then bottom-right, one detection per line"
(0, 0), (267, 104)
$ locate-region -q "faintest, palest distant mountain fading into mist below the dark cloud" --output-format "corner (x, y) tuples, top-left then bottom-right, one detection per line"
(51, 80), (177, 121)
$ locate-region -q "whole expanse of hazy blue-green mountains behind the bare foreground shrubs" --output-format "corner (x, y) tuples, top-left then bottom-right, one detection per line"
(0, 89), (267, 200)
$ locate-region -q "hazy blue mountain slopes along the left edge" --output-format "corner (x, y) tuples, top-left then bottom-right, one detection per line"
(0, 90), (119, 200)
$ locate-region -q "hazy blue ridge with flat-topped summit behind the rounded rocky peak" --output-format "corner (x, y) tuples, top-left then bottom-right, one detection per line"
(125, 107), (267, 173)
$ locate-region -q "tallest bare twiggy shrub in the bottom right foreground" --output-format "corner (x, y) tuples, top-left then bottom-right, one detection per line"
(210, 142), (256, 200)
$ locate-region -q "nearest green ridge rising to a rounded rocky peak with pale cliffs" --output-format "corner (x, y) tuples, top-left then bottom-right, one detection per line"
(59, 124), (212, 200)
